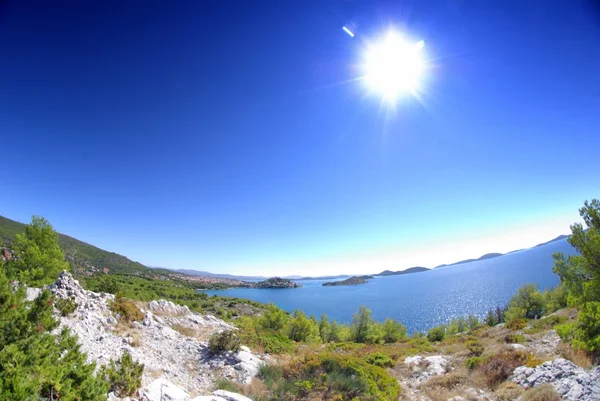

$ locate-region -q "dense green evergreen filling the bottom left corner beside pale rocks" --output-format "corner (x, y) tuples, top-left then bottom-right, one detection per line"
(0, 270), (108, 401)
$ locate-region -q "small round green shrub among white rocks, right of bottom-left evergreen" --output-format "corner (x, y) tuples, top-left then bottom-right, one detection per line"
(99, 352), (144, 397)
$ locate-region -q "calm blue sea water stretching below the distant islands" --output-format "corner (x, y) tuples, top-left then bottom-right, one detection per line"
(206, 240), (575, 333)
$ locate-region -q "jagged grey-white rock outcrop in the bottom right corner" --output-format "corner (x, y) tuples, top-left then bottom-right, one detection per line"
(511, 358), (600, 401)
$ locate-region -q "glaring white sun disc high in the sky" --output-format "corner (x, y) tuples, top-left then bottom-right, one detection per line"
(363, 31), (425, 102)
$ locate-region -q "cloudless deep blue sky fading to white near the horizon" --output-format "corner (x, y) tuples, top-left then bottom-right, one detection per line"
(0, 1), (600, 275)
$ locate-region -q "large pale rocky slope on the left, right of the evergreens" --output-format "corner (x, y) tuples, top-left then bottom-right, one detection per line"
(50, 272), (264, 401)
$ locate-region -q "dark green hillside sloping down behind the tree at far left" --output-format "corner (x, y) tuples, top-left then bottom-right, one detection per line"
(0, 216), (150, 274)
